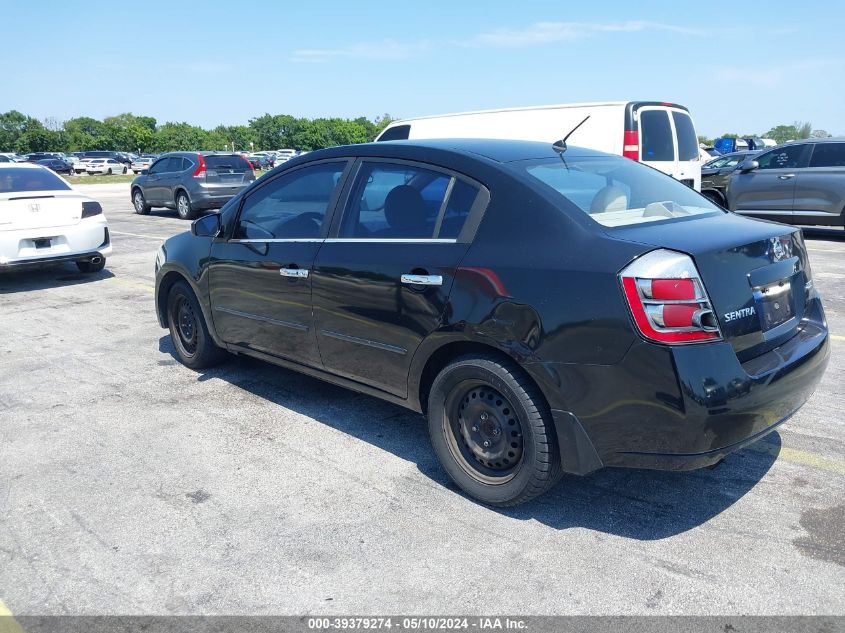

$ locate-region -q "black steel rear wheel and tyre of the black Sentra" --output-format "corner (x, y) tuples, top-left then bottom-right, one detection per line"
(428, 355), (560, 506)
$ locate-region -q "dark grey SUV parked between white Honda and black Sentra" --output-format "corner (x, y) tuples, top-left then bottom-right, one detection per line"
(130, 152), (255, 220)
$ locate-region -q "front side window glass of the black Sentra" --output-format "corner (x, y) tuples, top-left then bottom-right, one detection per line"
(235, 161), (346, 240)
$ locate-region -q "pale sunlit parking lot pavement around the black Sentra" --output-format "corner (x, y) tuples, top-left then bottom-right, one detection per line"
(0, 185), (845, 615)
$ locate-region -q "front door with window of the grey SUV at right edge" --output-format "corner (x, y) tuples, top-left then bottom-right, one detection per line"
(727, 143), (810, 222)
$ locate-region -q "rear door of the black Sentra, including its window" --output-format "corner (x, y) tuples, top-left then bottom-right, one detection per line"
(313, 159), (489, 397)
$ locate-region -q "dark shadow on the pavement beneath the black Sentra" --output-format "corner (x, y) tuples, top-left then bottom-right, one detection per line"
(159, 335), (781, 540)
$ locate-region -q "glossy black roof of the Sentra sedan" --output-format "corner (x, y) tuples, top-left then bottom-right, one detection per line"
(308, 138), (608, 163)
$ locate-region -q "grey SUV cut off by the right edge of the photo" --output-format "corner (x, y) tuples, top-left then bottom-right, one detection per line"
(726, 138), (845, 226)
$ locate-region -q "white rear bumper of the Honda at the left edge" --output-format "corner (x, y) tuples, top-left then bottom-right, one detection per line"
(0, 216), (112, 268)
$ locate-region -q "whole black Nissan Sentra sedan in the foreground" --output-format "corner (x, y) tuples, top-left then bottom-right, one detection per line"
(155, 140), (830, 505)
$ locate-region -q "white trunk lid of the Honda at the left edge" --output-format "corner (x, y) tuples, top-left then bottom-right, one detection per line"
(0, 191), (89, 231)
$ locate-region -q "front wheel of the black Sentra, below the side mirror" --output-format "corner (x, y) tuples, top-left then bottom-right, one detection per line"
(167, 281), (226, 369)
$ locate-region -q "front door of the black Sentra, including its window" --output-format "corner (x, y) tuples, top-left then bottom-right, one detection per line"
(209, 160), (349, 367)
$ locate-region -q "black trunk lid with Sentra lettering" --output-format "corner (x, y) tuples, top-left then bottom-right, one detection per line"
(612, 213), (811, 361)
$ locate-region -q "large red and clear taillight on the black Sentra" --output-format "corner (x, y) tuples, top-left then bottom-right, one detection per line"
(619, 250), (721, 344)
